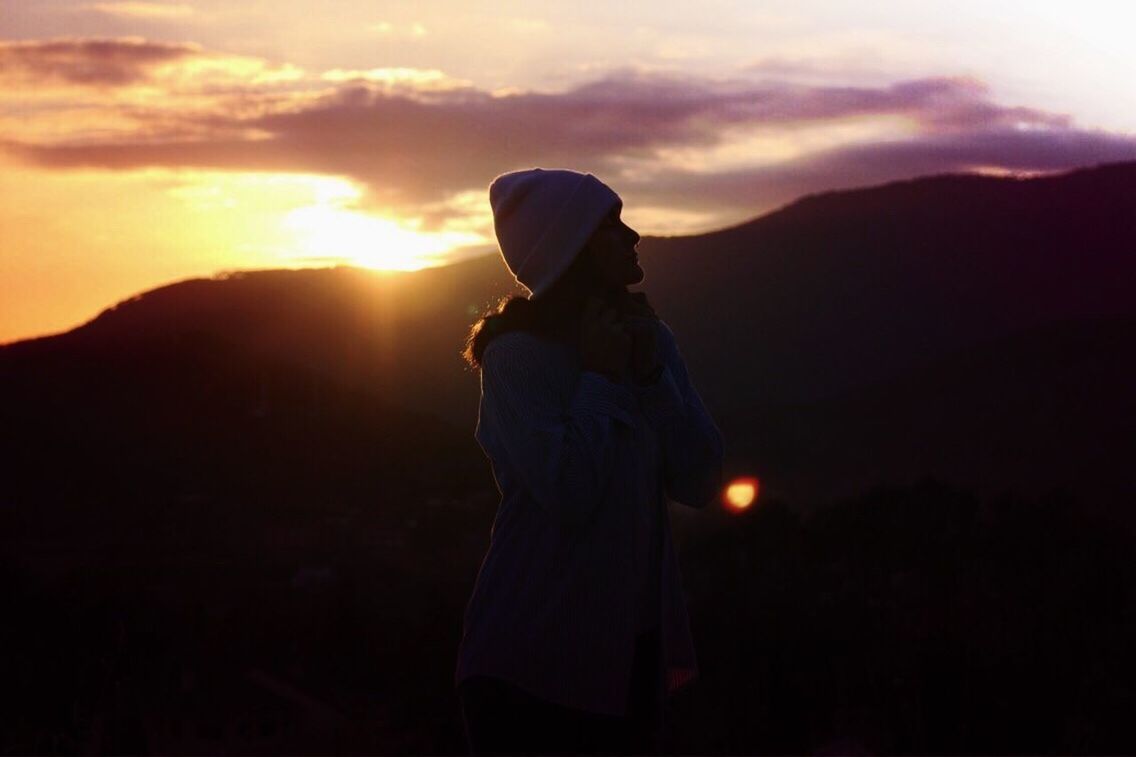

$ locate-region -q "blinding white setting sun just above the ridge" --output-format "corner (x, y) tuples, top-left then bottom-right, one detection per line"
(284, 177), (484, 271)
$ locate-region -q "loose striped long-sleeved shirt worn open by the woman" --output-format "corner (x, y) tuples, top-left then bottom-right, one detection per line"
(454, 321), (722, 716)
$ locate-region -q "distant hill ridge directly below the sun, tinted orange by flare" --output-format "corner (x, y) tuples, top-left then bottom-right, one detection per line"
(0, 259), (510, 424)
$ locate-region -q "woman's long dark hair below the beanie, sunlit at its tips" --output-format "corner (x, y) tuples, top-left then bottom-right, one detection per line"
(461, 244), (626, 368)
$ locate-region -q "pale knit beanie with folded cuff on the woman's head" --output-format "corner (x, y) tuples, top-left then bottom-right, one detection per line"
(490, 168), (621, 299)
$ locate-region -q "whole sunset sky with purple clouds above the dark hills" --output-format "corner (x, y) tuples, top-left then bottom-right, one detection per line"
(0, 0), (1136, 342)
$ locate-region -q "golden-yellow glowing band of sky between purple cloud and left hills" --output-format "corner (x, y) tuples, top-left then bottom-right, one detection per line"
(0, 167), (492, 343)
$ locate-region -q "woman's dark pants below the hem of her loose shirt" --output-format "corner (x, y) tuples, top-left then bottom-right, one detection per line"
(458, 630), (662, 755)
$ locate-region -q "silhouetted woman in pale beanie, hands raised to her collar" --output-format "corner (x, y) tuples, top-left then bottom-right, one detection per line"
(454, 168), (722, 755)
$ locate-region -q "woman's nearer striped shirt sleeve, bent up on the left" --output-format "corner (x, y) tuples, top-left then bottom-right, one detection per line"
(478, 332), (635, 527)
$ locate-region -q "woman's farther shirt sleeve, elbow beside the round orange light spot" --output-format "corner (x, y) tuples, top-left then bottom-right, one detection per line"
(636, 321), (725, 508)
